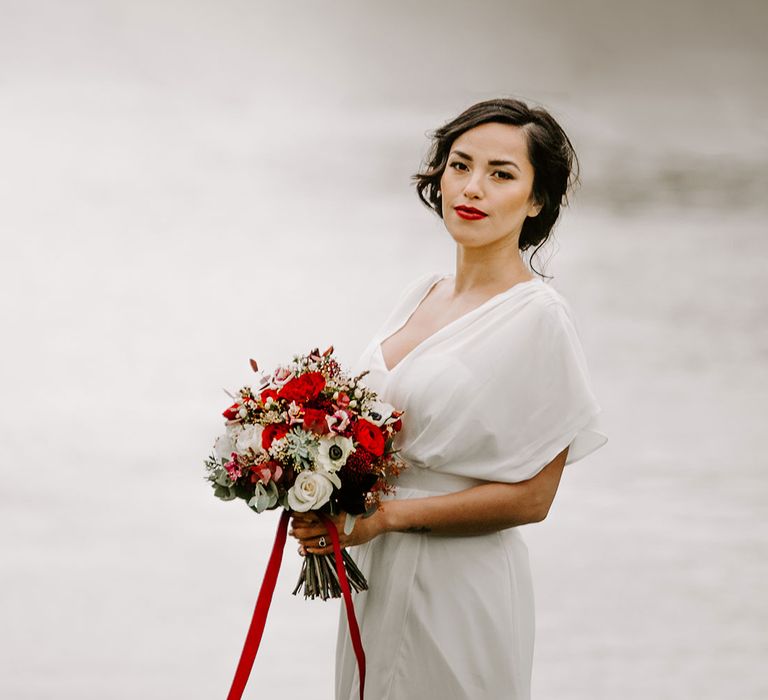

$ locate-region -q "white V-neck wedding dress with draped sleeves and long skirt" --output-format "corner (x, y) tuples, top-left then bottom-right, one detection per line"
(335, 273), (606, 700)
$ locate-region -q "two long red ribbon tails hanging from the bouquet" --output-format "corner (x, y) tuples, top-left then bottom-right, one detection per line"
(227, 510), (365, 700)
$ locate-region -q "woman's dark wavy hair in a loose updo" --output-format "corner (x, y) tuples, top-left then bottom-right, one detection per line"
(412, 98), (579, 270)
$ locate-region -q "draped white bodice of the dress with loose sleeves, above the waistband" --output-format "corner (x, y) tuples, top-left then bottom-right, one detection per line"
(358, 274), (607, 482)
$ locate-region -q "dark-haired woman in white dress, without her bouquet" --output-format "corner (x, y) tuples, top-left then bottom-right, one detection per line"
(292, 99), (606, 700)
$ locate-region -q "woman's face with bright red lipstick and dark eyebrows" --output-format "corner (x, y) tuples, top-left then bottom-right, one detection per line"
(440, 122), (541, 247)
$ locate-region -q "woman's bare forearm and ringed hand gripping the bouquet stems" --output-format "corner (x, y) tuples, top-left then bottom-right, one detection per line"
(290, 447), (568, 554)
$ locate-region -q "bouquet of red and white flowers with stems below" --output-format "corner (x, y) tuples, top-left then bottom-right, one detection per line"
(205, 346), (404, 600)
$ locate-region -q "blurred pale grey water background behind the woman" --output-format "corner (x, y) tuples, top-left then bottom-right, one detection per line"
(0, 0), (768, 700)
